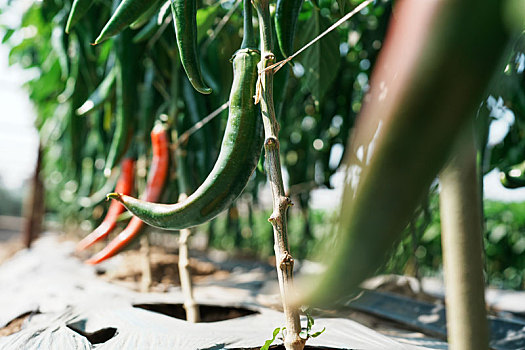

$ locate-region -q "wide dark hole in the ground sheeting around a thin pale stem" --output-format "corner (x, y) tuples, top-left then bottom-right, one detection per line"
(133, 304), (258, 322)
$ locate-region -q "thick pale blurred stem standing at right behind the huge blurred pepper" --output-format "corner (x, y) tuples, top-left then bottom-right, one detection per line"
(440, 121), (489, 350)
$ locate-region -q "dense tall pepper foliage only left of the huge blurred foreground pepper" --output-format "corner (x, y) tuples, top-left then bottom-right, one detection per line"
(3, 0), (390, 246)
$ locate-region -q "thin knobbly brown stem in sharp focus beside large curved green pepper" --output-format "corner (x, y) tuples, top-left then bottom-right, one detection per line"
(253, 0), (306, 350)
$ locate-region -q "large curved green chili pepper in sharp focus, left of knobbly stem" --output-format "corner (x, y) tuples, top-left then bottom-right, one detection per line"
(108, 12), (264, 230)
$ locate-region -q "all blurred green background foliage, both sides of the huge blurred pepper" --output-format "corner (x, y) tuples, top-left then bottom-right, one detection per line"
(2, 0), (525, 288)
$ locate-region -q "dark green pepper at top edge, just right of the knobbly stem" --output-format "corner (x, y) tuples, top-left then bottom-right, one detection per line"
(275, 0), (304, 57)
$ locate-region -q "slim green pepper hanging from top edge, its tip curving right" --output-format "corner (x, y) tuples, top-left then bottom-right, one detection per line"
(171, 0), (212, 94)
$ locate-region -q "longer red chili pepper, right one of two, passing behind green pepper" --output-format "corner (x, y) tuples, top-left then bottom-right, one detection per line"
(86, 124), (169, 265)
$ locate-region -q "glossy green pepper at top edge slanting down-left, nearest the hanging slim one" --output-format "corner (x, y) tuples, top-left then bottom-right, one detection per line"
(95, 0), (160, 45)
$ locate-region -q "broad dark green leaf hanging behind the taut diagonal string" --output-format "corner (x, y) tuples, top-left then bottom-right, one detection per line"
(301, 10), (340, 101)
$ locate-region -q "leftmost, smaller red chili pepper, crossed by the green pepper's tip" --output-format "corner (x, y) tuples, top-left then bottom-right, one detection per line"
(77, 158), (135, 251)
